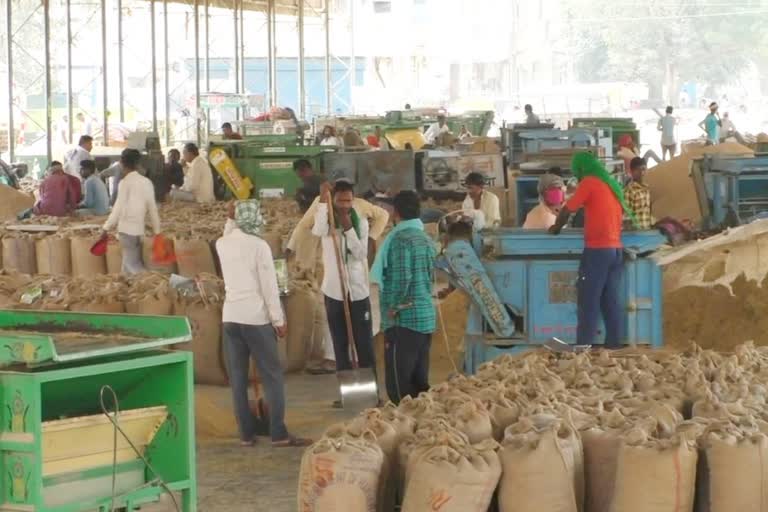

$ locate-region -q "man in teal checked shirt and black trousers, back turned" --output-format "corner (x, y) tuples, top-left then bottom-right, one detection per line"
(371, 190), (437, 404)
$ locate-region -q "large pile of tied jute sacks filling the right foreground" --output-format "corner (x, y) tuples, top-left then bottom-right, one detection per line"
(298, 344), (768, 512)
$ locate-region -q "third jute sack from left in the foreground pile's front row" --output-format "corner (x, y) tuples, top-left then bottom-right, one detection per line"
(499, 415), (584, 512)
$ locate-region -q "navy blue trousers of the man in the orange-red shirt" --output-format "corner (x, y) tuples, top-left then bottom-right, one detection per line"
(576, 249), (624, 348)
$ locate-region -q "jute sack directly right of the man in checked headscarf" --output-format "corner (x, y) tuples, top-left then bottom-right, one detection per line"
(283, 288), (317, 372)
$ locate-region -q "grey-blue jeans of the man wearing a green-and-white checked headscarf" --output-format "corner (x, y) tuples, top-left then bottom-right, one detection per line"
(224, 322), (288, 441)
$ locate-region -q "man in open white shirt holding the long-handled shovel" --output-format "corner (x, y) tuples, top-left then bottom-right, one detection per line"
(312, 180), (376, 407)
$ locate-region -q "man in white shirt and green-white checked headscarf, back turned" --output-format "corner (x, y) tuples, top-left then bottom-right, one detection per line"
(216, 199), (310, 447)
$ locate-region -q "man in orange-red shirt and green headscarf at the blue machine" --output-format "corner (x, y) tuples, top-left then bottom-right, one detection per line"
(549, 153), (632, 348)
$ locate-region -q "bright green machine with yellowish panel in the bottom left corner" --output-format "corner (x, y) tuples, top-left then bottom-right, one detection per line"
(0, 310), (197, 512)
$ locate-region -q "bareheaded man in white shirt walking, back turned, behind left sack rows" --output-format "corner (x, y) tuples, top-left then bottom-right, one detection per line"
(104, 149), (160, 274)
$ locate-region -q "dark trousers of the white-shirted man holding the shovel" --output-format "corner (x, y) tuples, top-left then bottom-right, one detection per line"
(325, 296), (376, 371)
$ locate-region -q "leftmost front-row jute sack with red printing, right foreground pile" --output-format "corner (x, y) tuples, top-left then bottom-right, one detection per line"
(297, 431), (384, 512)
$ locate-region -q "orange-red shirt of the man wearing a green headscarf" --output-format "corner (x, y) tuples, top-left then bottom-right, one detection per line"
(565, 176), (624, 249)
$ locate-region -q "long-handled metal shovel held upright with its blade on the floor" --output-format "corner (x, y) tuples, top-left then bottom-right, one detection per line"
(326, 194), (379, 411)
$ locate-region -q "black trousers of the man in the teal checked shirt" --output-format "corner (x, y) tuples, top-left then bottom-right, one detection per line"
(384, 327), (432, 404)
